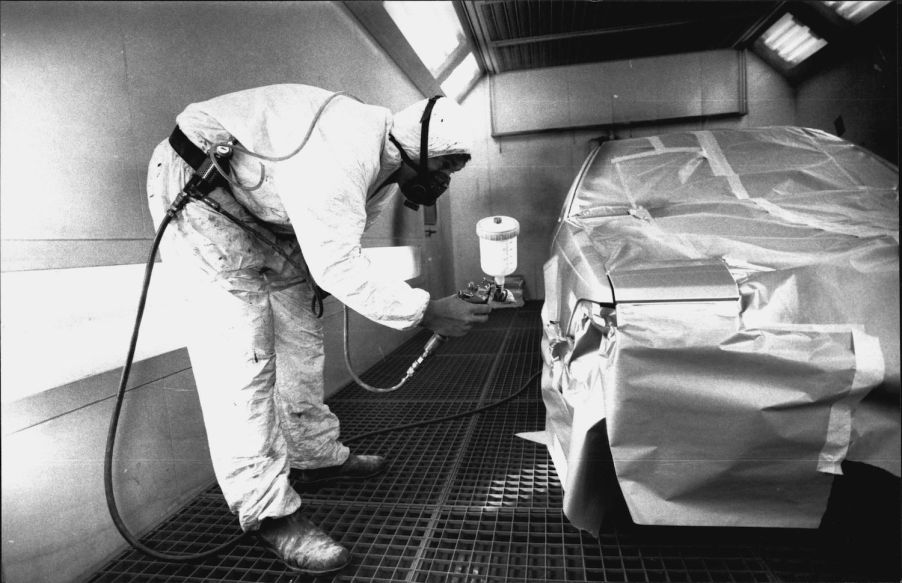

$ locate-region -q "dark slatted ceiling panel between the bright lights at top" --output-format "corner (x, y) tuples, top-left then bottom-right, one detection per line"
(456, 0), (782, 73)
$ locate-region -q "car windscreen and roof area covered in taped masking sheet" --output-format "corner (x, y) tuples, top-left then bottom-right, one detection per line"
(570, 127), (898, 215)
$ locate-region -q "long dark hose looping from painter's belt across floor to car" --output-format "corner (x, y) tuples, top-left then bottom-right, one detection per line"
(103, 213), (539, 563)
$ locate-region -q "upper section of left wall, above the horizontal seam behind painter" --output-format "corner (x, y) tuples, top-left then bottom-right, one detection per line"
(0, 2), (423, 271)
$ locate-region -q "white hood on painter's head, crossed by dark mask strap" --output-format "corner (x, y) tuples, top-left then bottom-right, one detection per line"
(391, 97), (473, 160)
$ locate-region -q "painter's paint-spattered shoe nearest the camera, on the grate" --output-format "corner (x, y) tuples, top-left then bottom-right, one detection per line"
(257, 511), (351, 575)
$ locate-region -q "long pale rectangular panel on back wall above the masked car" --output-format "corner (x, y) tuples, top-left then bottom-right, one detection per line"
(491, 50), (746, 136)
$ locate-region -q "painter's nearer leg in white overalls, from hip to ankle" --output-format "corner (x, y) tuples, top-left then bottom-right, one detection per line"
(147, 142), (300, 530)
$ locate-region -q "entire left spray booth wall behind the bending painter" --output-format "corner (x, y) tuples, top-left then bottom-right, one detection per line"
(0, 2), (452, 583)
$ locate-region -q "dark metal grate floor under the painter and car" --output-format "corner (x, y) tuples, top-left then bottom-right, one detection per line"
(90, 302), (899, 583)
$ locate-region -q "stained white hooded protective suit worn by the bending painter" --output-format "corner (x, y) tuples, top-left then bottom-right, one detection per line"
(147, 85), (470, 530)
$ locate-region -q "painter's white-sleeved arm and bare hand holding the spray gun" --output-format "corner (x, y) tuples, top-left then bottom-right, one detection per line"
(276, 101), (490, 336)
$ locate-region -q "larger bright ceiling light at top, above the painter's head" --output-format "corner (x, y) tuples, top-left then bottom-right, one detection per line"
(382, 0), (466, 77)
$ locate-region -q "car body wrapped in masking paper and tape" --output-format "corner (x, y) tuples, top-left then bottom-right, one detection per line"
(542, 127), (900, 531)
